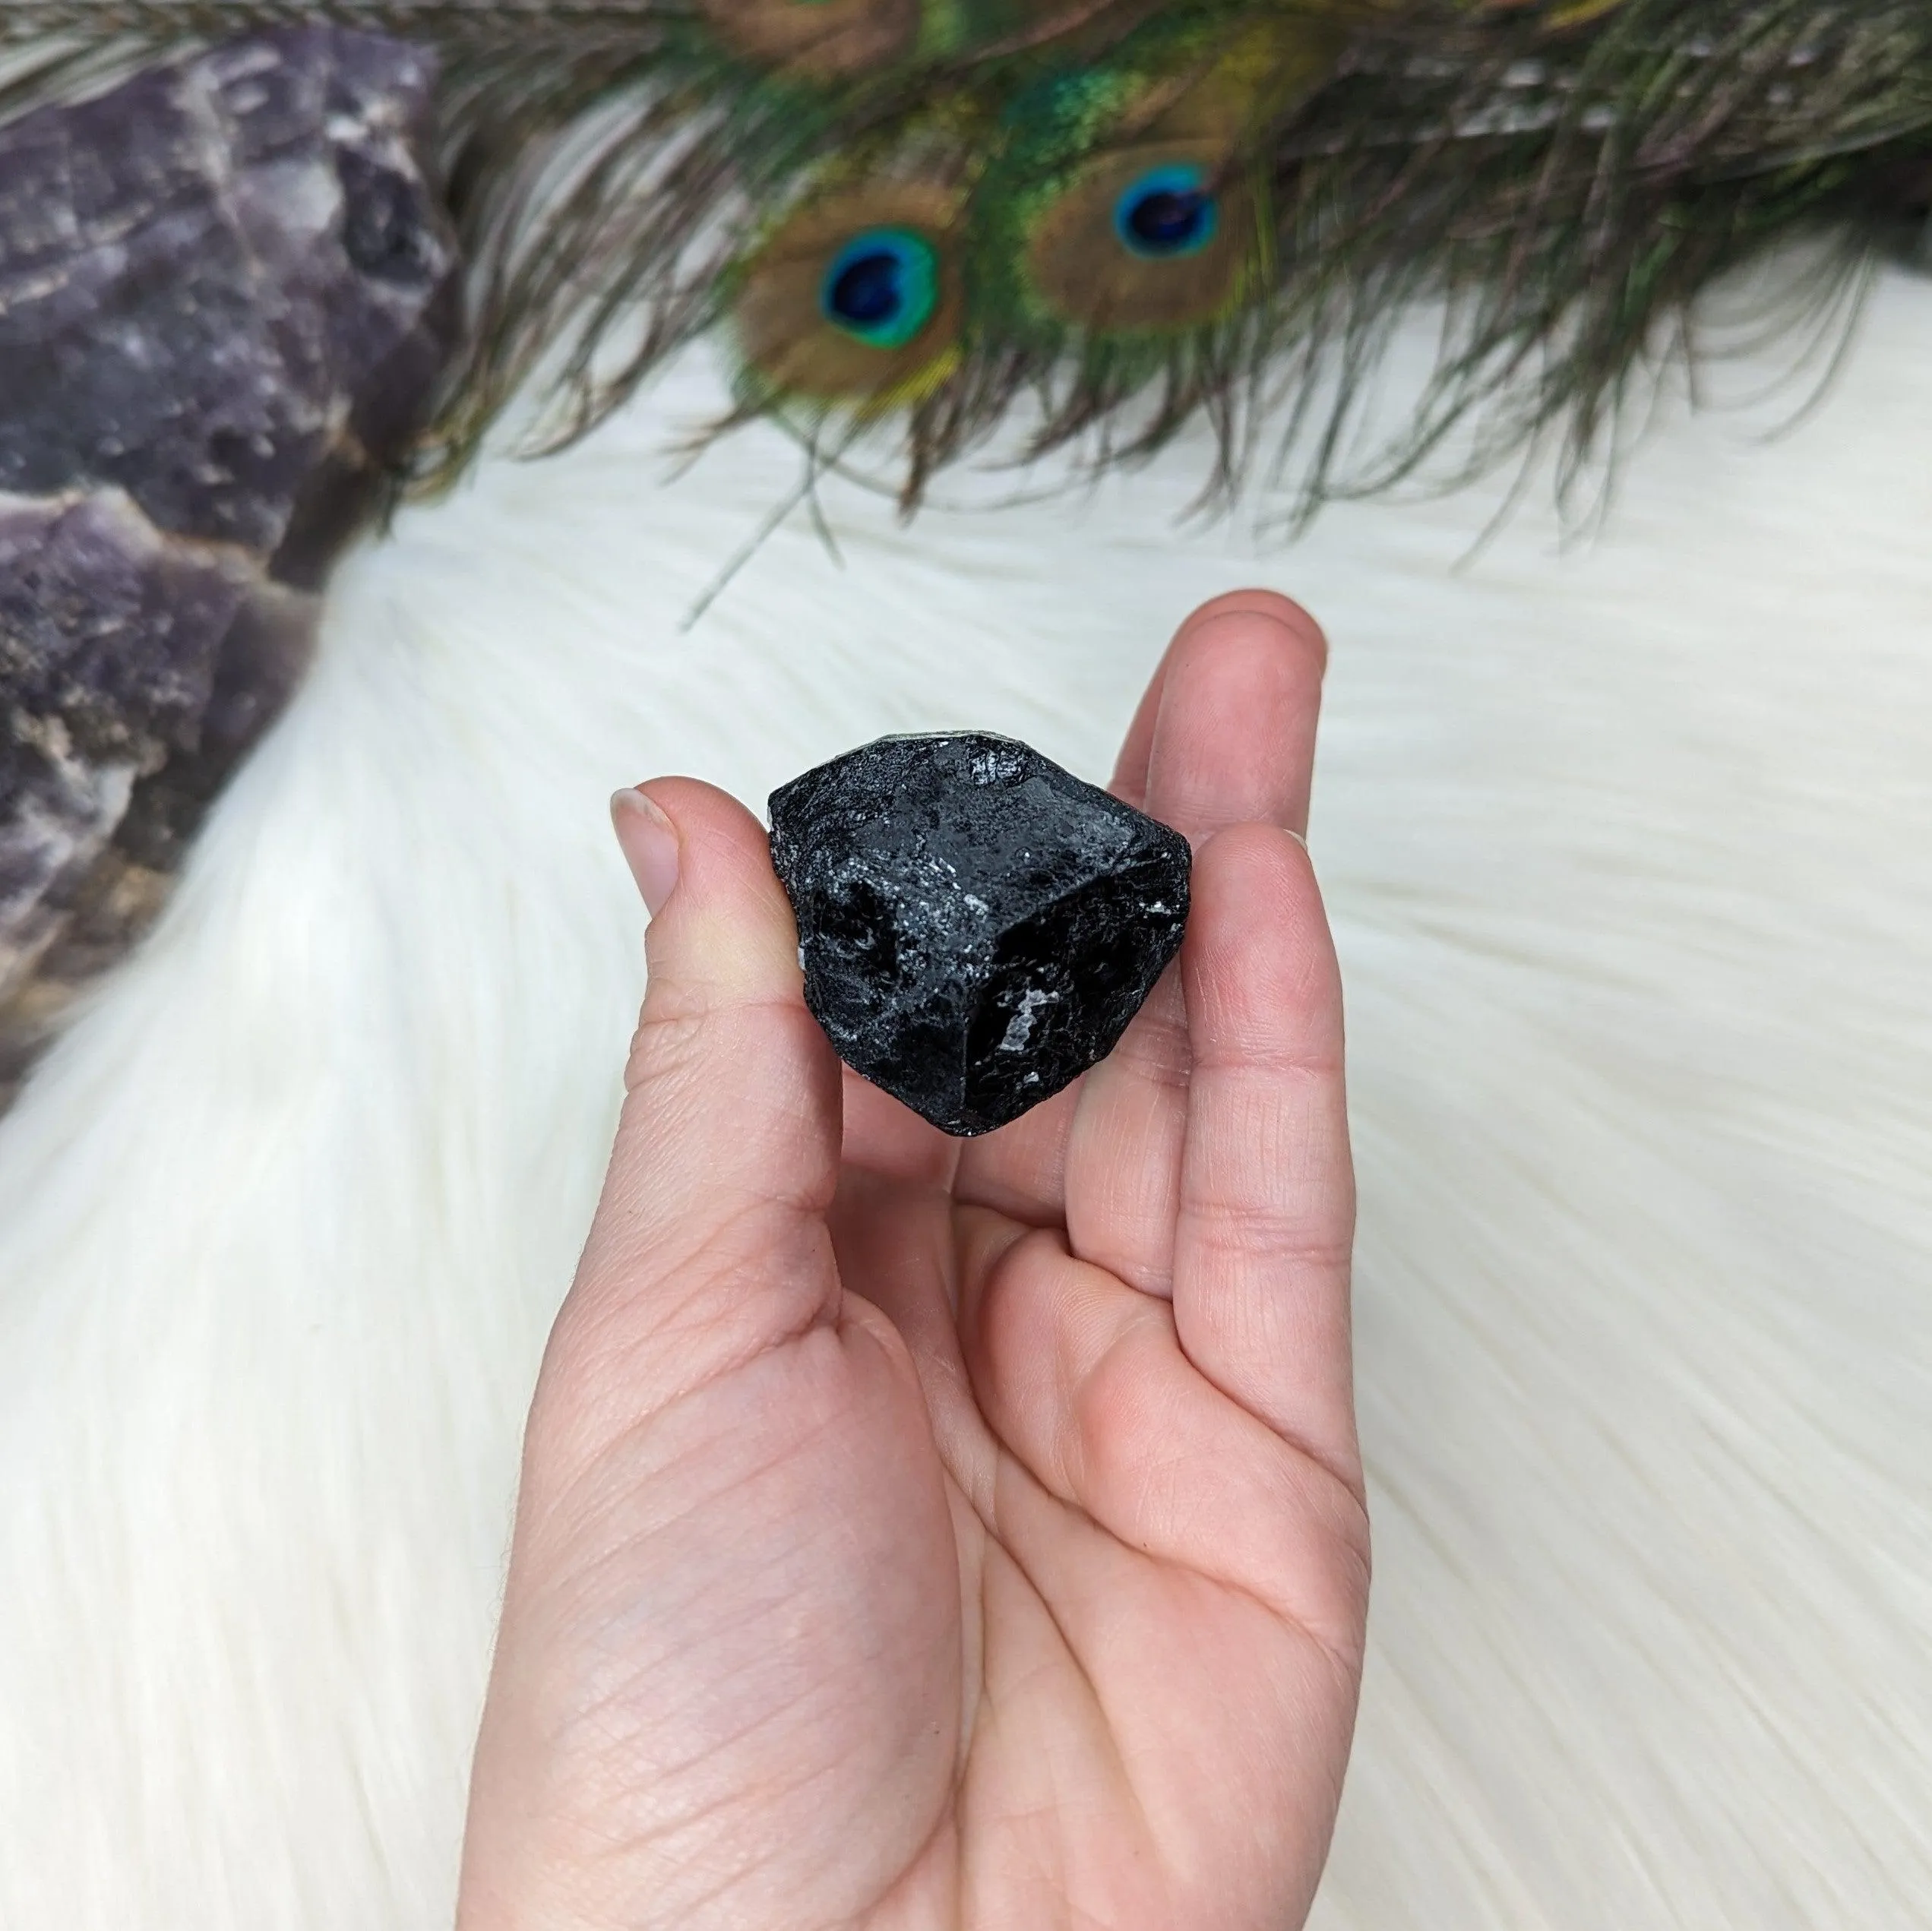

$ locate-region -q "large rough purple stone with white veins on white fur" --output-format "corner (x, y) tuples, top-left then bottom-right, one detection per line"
(0, 27), (456, 1105)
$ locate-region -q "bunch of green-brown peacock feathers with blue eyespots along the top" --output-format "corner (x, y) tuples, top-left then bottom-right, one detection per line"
(0, 0), (1932, 510)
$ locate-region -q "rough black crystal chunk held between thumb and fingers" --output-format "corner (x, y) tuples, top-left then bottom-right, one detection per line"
(771, 732), (1190, 1133)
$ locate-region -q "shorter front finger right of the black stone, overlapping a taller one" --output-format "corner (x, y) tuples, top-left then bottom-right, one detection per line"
(1173, 824), (1362, 1496)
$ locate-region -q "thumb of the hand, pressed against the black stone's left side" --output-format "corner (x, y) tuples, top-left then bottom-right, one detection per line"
(547, 778), (840, 1427)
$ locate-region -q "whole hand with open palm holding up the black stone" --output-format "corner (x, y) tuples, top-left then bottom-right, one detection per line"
(458, 593), (1368, 1931)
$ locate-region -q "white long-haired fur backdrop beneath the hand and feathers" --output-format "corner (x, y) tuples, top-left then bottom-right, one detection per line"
(0, 264), (1932, 1931)
